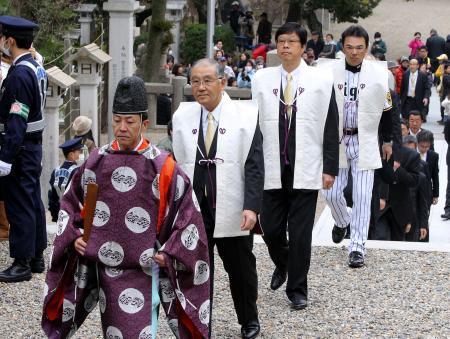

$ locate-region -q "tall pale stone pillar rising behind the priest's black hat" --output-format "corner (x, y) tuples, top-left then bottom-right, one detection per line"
(103, 0), (139, 140)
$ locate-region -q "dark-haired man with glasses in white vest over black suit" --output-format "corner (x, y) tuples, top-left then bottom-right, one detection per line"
(252, 23), (339, 310)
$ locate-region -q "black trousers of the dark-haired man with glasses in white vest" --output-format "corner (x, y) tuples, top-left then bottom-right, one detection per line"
(261, 169), (318, 299)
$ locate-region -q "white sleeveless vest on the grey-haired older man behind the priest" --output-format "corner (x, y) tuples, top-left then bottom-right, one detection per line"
(172, 92), (258, 238)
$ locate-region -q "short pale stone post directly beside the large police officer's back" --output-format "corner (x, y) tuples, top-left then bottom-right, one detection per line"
(41, 96), (63, 209)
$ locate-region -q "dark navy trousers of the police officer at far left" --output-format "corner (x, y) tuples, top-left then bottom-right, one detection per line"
(0, 142), (47, 259)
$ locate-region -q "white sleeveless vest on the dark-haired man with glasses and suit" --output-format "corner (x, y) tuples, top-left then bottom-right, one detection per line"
(252, 60), (333, 190)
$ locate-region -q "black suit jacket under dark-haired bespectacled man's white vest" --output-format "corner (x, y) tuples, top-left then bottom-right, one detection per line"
(278, 86), (339, 181)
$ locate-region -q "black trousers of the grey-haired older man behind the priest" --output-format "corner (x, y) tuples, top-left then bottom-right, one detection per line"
(200, 198), (258, 328)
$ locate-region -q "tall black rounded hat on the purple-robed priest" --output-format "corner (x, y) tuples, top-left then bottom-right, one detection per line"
(113, 76), (148, 114)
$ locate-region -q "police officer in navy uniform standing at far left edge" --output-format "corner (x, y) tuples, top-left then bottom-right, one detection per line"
(0, 16), (47, 282)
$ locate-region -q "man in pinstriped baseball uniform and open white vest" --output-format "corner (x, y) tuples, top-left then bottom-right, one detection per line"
(324, 25), (392, 268)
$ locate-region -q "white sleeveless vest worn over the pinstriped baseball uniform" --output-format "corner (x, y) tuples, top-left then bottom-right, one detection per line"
(324, 58), (389, 170)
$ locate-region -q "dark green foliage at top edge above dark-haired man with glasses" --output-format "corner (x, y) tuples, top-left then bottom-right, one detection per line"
(286, 0), (381, 33)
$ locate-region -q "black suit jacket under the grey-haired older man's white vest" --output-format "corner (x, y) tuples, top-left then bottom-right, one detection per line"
(193, 113), (264, 215)
